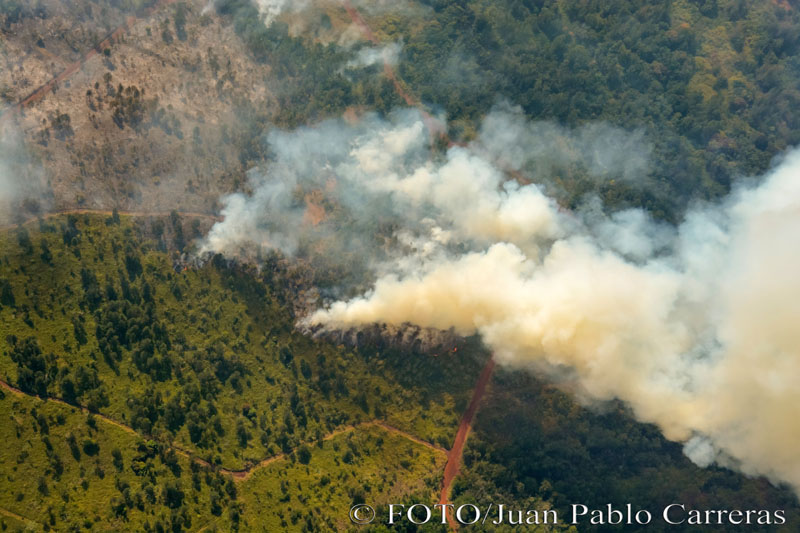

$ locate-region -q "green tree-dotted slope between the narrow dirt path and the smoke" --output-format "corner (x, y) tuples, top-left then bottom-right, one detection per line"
(0, 215), (482, 468)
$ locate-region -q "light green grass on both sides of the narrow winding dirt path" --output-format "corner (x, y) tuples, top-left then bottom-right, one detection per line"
(0, 215), (485, 531)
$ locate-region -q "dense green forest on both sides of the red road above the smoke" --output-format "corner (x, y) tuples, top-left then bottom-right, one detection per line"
(217, 0), (800, 221)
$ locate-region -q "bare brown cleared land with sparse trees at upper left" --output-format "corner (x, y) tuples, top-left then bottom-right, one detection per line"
(0, 0), (277, 222)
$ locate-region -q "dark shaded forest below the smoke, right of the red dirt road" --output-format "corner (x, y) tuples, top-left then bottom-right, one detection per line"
(452, 370), (800, 533)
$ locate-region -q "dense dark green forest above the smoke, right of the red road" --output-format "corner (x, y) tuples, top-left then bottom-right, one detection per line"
(400, 0), (800, 214)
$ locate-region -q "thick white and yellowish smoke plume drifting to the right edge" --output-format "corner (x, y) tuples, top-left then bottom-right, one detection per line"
(204, 109), (800, 489)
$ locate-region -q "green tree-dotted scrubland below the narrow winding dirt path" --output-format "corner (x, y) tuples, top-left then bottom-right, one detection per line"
(0, 384), (444, 532)
